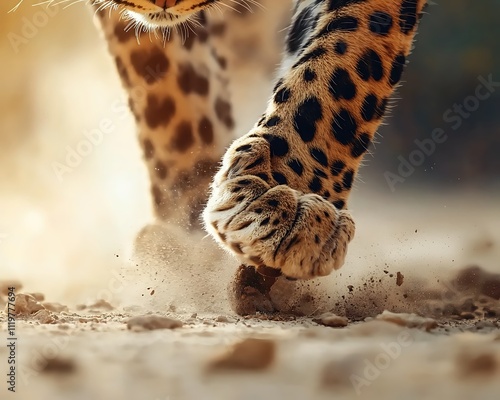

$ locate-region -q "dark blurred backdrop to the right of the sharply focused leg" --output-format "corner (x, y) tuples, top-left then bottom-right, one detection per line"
(373, 0), (500, 190)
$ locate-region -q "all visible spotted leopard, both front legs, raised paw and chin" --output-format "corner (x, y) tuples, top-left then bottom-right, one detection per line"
(94, 0), (425, 279)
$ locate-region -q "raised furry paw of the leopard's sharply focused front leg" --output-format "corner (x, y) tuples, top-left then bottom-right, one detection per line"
(204, 139), (354, 279)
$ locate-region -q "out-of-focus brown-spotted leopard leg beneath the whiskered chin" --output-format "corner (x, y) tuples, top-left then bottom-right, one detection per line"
(92, 10), (229, 228)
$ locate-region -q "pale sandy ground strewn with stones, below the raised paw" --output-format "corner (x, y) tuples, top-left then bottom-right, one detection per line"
(0, 278), (500, 400)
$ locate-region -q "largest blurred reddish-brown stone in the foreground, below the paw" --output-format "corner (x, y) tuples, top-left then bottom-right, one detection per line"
(209, 338), (276, 370)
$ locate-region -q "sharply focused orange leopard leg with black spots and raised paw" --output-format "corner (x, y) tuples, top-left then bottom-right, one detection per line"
(204, 0), (425, 279)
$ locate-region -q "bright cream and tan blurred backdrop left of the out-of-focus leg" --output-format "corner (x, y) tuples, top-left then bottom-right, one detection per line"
(0, 0), (151, 300)
